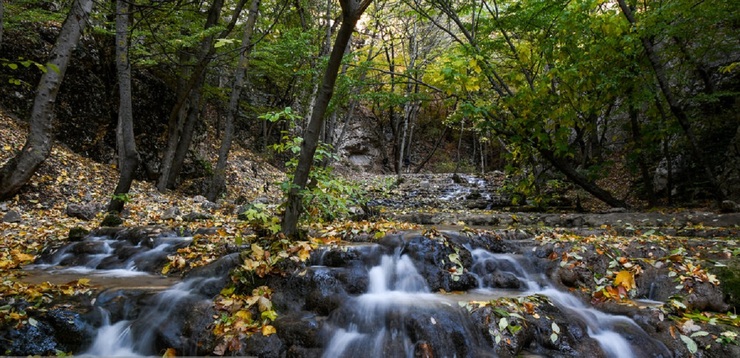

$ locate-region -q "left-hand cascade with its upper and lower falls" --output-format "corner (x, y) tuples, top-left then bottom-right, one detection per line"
(26, 234), (222, 357)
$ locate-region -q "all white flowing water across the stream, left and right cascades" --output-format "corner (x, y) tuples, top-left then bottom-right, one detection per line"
(26, 231), (670, 358)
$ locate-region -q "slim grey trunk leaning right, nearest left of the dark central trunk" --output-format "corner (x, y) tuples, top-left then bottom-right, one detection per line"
(206, 0), (260, 201)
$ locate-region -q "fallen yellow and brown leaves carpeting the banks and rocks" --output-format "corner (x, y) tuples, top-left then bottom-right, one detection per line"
(0, 115), (740, 353)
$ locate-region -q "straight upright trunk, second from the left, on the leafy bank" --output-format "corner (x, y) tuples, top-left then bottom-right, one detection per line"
(108, 0), (139, 213)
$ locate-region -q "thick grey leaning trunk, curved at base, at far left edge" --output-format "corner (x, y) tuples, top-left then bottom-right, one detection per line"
(0, 0), (93, 200)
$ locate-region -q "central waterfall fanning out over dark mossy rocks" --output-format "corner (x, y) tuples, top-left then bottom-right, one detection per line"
(323, 250), (488, 358)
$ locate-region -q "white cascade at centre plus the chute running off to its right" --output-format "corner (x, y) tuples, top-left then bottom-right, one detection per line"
(323, 245), (670, 358)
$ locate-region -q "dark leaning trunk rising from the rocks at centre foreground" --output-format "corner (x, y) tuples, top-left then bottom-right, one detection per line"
(281, 0), (372, 237)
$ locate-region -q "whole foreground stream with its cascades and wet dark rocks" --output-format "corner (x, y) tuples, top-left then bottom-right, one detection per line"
(11, 227), (684, 357)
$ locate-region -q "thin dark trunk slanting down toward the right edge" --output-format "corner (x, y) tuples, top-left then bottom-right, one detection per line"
(618, 0), (725, 201)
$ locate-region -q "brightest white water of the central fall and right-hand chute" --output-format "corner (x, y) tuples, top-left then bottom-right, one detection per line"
(323, 249), (668, 358)
